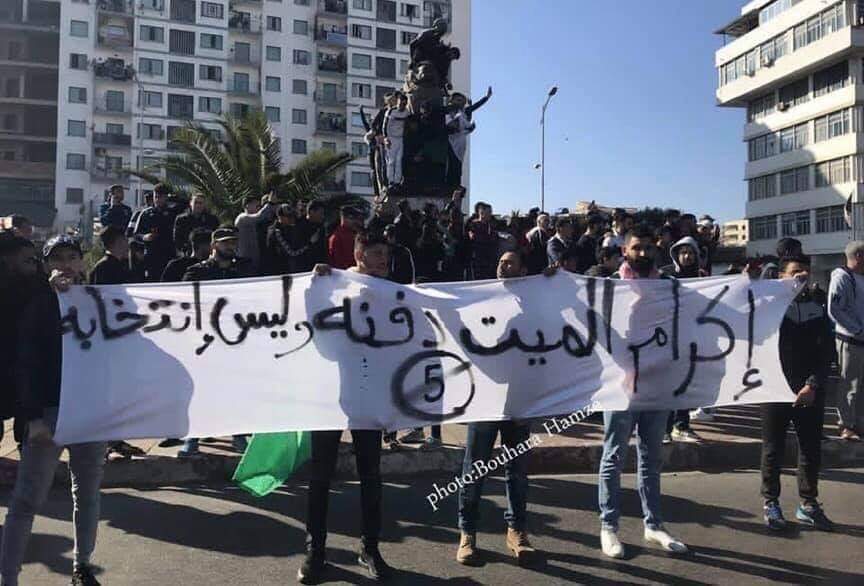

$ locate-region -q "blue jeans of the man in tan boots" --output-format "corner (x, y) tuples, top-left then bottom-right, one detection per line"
(459, 421), (531, 534)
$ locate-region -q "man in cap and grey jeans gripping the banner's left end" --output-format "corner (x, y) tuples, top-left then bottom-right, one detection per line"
(0, 236), (106, 586)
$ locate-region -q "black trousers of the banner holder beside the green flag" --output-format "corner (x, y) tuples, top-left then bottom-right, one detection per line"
(306, 429), (381, 551)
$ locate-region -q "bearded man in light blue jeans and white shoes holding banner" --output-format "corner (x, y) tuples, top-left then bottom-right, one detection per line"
(599, 226), (687, 558)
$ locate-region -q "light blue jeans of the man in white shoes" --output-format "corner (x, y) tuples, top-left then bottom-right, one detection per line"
(599, 411), (669, 531)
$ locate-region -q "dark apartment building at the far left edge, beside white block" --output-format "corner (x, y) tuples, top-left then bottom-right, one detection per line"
(0, 0), (60, 227)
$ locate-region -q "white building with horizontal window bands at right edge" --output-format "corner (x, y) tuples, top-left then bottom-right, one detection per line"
(715, 0), (864, 274)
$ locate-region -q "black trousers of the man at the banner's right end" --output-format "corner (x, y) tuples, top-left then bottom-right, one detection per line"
(762, 393), (825, 503)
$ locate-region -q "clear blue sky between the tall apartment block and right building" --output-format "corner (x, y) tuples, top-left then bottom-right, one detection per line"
(470, 0), (746, 221)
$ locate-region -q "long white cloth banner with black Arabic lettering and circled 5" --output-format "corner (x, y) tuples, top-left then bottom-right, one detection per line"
(56, 271), (796, 444)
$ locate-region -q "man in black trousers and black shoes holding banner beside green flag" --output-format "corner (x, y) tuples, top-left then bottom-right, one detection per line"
(297, 233), (393, 584)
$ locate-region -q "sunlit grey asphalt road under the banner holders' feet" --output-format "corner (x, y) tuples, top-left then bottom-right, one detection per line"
(0, 468), (864, 586)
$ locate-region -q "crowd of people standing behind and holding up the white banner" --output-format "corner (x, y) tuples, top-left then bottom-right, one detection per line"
(0, 185), (864, 586)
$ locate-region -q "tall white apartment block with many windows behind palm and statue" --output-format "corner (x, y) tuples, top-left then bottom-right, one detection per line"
(52, 0), (471, 229)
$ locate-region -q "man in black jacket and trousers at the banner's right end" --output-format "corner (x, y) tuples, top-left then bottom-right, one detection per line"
(762, 255), (834, 531)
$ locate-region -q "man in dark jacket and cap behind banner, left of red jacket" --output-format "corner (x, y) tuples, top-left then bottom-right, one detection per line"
(177, 228), (256, 458)
